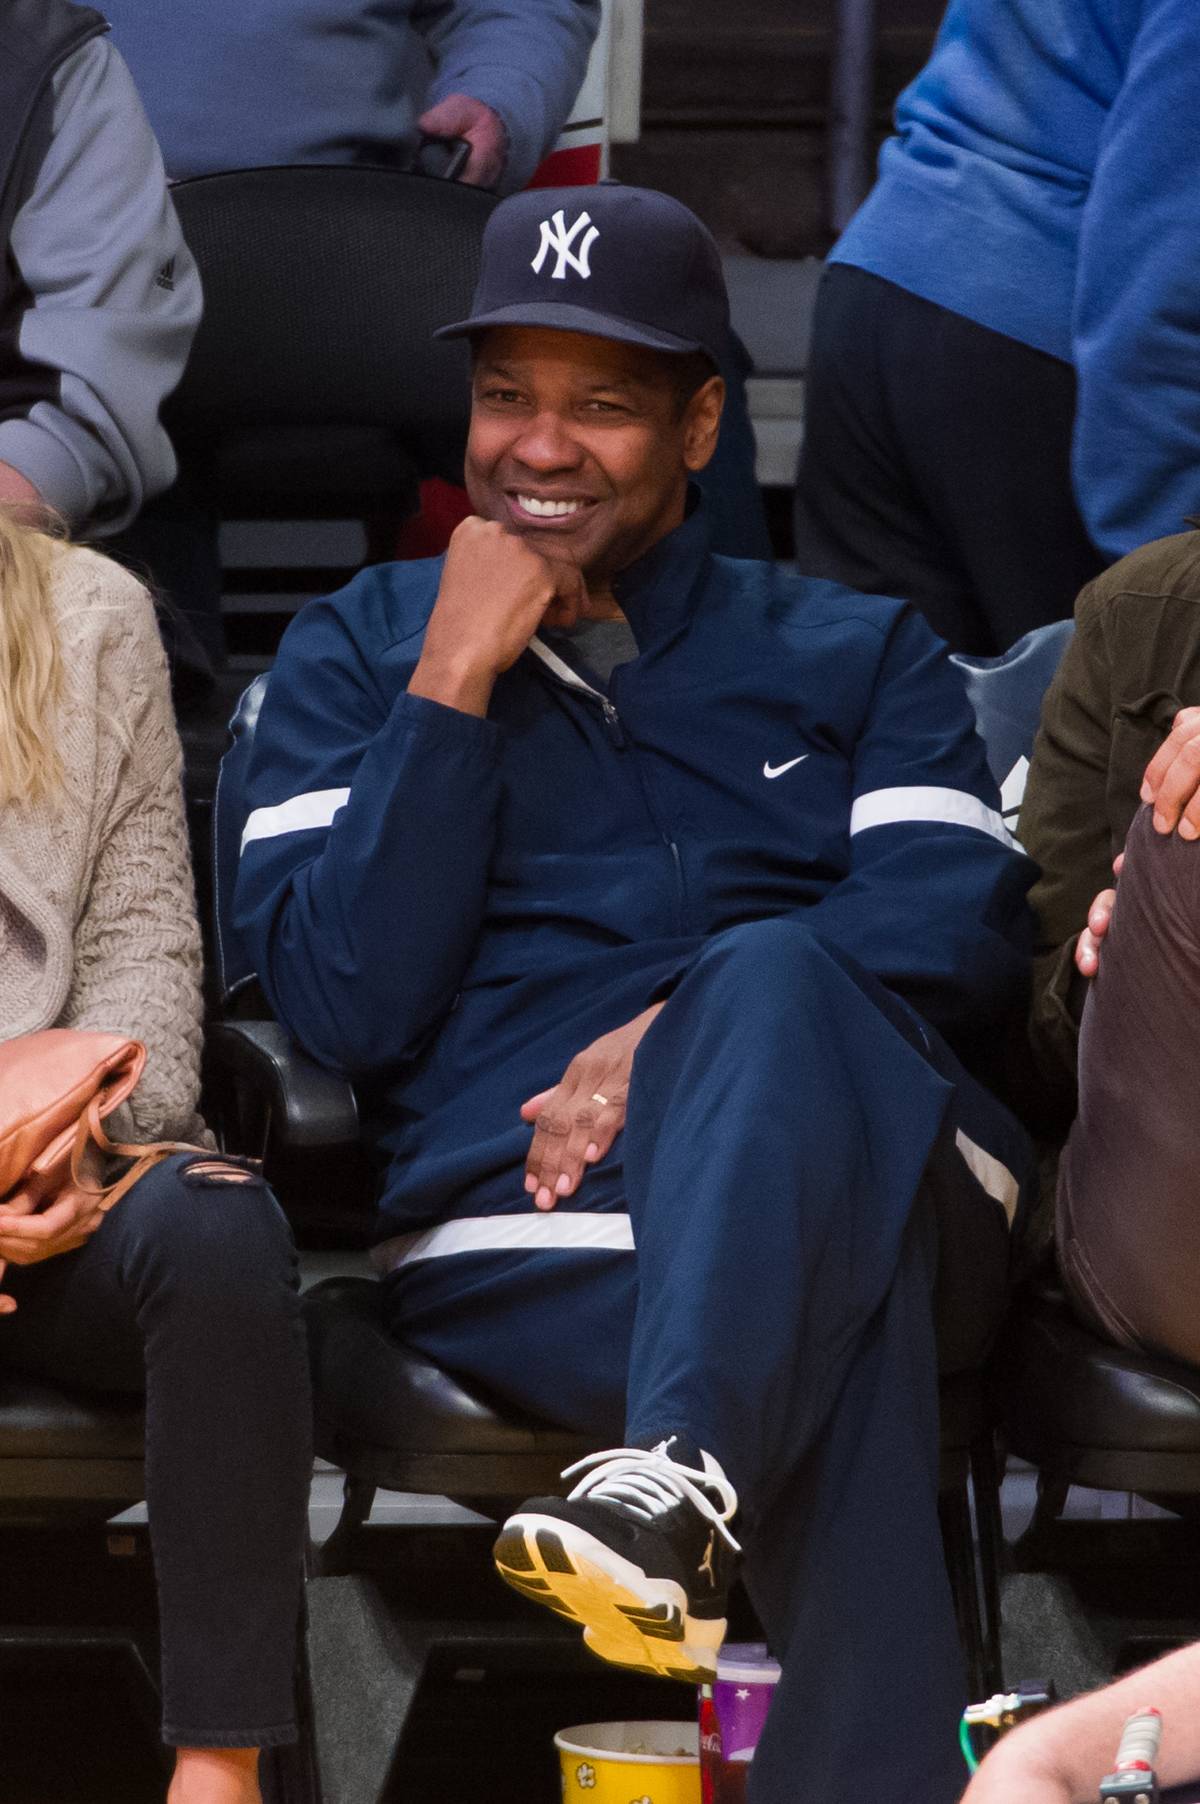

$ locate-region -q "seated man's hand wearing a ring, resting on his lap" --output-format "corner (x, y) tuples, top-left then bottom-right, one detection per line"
(522, 1003), (662, 1209)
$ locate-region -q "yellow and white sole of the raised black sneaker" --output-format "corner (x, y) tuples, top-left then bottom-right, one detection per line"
(493, 1515), (725, 1685)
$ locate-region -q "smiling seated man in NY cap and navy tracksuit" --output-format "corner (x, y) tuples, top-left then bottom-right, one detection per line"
(236, 186), (1032, 1804)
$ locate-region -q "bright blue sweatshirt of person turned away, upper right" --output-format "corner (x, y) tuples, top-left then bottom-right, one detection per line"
(832, 0), (1200, 557)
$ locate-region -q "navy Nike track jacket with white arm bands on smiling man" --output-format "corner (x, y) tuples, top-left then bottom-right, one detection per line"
(235, 512), (1032, 1225)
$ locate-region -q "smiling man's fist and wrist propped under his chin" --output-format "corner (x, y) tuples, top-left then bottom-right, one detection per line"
(408, 514), (586, 714)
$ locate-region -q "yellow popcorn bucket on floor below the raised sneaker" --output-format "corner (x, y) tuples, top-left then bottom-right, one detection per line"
(554, 1723), (700, 1804)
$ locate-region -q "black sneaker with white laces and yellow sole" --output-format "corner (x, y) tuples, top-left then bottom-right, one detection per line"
(493, 1436), (740, 1685)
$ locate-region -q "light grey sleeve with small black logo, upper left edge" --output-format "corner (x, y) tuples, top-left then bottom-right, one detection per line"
(0, 38), (200, 532)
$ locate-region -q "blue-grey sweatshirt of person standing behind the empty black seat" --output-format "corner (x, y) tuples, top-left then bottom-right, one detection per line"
(105, 0), (599, 193)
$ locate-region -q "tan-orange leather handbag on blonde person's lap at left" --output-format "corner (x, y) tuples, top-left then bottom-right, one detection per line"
(0, 1026), (193, 1214)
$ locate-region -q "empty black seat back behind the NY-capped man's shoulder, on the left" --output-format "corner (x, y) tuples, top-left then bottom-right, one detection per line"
(164, 166), (496, 497)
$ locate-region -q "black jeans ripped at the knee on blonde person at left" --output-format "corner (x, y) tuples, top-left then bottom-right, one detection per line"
(0, 1155), (312, 1748)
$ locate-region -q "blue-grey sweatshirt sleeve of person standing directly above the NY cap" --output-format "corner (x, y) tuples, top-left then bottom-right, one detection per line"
(411, 0), (599, 195)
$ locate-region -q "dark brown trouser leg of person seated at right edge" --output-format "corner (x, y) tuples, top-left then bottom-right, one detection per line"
(1057, 808), (1200, 1364)
